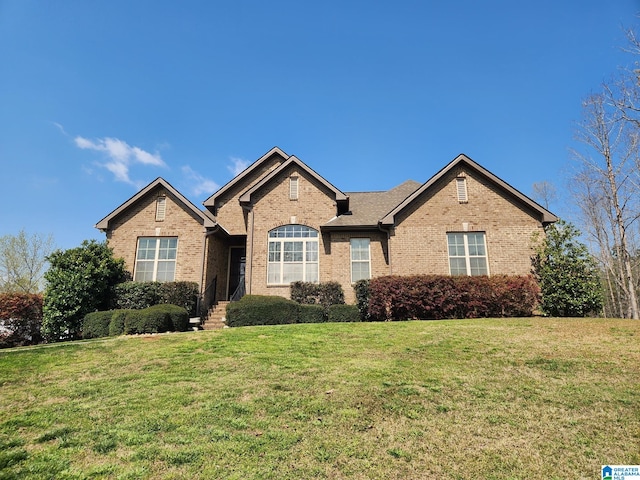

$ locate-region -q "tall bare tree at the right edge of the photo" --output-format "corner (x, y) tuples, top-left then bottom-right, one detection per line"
(573, 93), (640, 319)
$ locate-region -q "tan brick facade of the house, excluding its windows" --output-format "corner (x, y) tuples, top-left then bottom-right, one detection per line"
(97, 148), (557, 305)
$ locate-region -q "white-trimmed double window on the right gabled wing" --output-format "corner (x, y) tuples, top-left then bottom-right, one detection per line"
(447, 232), (489, 275)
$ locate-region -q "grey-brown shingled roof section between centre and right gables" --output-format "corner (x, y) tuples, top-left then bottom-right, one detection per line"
(322, 180), (420, 229)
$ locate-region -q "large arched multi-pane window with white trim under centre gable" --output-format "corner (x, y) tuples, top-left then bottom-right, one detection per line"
(267, 225), (318, 285)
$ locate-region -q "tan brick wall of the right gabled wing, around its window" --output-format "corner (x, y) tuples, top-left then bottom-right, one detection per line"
(390, 171), (542, 275)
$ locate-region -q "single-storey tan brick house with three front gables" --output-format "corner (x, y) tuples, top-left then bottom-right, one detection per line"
(96, 147), (557, 312)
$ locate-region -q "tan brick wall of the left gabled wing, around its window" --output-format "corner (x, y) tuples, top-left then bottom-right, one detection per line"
(107, 187), (204, 284)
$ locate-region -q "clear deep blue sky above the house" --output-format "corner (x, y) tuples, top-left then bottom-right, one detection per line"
(0, 0), (640, 248)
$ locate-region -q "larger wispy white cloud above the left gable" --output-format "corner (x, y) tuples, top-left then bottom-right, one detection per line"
(74, 136), (167, 188)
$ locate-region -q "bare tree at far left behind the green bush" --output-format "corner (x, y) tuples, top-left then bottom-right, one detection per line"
(0, 230), (53, 293)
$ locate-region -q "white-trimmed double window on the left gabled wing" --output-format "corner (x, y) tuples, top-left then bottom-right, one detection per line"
(133, 237), (178, 282)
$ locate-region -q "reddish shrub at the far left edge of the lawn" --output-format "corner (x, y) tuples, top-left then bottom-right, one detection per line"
(0, 293), (42, 348)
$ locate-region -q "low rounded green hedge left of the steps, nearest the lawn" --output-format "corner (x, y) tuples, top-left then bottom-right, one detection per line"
(82, 304), (189, 338)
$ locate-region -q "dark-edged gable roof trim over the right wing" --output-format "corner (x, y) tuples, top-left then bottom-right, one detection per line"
(380, 153), (558, 226)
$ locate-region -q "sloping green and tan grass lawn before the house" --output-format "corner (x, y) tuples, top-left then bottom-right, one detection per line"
(0, 319), (640, 480)
